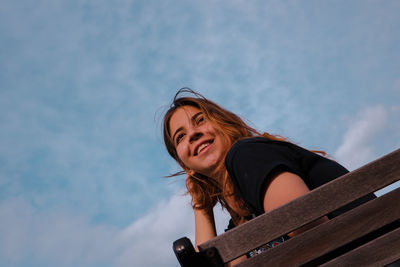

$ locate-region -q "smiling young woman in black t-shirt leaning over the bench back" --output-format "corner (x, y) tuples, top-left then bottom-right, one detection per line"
(163, 88), (374, 264)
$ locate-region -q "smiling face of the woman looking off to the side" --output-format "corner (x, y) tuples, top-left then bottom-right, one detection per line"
(169, 106), (227, 177)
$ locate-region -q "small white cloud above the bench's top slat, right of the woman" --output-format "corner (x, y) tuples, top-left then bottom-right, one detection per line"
(335, 106), (387, 169)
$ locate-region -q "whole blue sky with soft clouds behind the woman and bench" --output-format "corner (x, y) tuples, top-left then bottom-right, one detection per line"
(0, 0), (400, 266)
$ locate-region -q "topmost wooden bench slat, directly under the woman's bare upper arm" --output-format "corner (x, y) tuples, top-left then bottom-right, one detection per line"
(199, 149), (400, 262)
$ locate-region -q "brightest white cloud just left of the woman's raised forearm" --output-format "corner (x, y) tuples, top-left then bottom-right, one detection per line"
(116, 188), (228, 266)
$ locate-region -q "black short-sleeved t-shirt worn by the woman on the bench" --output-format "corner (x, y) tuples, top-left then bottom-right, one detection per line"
(225, 137), (375, 217)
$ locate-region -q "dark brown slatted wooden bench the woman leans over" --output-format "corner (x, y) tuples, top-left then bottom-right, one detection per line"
(173, 149), (400, 267)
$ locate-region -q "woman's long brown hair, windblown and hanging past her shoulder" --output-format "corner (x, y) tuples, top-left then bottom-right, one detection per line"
(163, 88), (287, 224)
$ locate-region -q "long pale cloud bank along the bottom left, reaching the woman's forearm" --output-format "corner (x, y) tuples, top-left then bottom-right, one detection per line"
(0, 191), (228, 267)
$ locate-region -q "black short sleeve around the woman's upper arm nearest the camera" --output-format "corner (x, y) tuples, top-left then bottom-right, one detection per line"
(225, 138), (304, 216)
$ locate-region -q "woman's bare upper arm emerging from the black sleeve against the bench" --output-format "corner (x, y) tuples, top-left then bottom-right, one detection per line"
(263, 172), (328, 237)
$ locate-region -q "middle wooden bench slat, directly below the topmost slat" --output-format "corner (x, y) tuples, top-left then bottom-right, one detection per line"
(237, 188), (400, 267)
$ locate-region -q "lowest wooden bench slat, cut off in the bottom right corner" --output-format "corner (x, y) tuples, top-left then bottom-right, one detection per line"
(321, 228), (400, 267)
